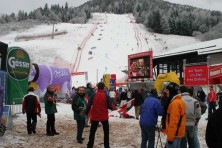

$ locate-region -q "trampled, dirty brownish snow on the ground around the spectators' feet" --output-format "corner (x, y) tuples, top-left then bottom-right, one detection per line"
(0, 103), (207, 148)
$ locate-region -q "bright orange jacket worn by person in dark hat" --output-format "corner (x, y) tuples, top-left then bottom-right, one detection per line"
(166, 95), (186, 141)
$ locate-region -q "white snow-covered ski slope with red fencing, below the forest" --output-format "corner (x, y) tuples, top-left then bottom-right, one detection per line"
(0, 13), (199, 86)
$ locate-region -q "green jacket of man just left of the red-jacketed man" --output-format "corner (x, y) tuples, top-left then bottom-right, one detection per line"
(72, 93), (86, 120)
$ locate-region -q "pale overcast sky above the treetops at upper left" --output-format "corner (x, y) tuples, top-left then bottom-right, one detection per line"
(0, 0), (89, 14)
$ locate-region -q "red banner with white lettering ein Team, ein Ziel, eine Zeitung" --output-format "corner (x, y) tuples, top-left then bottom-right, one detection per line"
(184, 65), (209, 86)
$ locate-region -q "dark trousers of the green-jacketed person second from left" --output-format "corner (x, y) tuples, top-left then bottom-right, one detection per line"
(46, 114), (56, 134)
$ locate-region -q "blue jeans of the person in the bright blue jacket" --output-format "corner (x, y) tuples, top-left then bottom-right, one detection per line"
(140, 125), (155, 148)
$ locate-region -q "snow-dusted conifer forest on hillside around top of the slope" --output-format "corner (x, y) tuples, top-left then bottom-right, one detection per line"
(0, 0), (222, 41)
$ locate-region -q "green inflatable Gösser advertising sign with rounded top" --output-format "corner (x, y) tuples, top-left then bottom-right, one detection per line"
(6, 47), (31, 104)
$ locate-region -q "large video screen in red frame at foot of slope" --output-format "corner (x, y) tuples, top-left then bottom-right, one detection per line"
(128, 51), (153, 79)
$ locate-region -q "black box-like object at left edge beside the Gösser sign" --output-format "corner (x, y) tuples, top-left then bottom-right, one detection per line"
(0, 42), (8, 71)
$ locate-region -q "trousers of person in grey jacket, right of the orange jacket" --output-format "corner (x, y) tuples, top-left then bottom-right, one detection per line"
(180, 126), (196, 148)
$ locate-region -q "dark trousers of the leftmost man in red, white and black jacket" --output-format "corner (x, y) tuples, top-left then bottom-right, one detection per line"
(26, 113), (37, 133)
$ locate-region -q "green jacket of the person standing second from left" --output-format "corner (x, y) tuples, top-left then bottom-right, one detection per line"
(44, 92), (57, 115)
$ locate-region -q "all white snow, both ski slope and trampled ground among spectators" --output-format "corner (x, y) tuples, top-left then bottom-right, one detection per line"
(0, 13), (206, 148)
